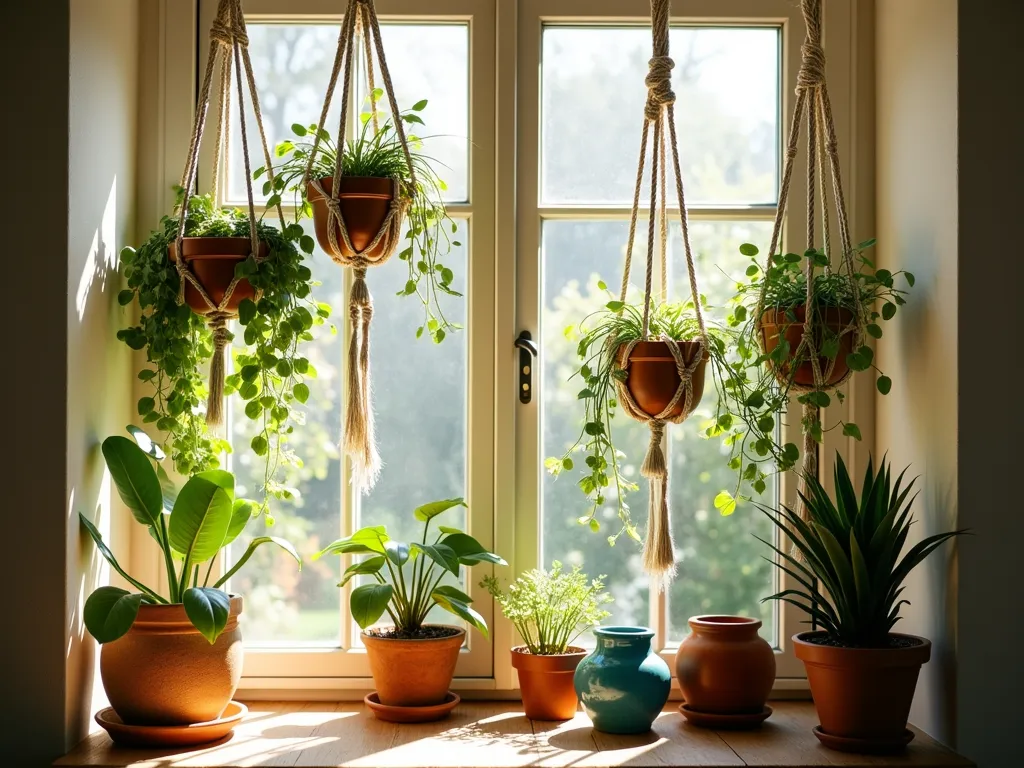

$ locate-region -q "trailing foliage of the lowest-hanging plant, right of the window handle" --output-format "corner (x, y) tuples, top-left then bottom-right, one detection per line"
(544, 282), (764, 546)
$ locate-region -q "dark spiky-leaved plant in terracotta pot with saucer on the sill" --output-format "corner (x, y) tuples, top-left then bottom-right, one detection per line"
(762, 455), (967, 752)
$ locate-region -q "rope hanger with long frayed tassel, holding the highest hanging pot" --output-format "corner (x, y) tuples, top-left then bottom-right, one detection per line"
(302, 0), (418, 493)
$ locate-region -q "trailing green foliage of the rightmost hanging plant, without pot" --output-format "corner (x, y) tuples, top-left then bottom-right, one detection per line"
(709, 240), (914, 508)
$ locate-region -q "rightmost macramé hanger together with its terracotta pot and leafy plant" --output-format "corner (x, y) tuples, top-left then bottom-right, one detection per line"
(740, 0), (913, 524)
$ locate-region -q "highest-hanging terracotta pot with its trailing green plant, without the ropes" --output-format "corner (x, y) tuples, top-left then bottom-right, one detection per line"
(256, 96), (462, 343)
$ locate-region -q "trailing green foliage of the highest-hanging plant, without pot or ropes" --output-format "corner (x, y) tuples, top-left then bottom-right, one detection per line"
(253, 88), (462, 344)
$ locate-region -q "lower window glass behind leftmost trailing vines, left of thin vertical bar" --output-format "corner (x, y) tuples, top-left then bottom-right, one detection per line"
(228, 219), (347, 645)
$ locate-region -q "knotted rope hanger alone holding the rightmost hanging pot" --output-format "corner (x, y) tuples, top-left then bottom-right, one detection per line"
(755, 0), (865, 520)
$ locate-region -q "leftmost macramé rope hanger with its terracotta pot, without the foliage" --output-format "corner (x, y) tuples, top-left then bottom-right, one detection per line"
(170, 0), (285, 427)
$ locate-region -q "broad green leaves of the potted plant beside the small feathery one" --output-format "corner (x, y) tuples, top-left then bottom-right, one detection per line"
(313, 499), (508, 639)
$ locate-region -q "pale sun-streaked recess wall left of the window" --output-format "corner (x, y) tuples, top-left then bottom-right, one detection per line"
(65, 0), (138, 745)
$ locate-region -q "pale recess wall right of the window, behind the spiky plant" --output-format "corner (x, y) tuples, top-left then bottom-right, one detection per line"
(874, 0), (957, 743)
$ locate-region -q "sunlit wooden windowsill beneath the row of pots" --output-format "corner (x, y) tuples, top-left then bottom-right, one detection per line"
(55, 701), (973, 768)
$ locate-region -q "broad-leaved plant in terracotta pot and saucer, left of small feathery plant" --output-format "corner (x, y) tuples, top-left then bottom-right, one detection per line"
(313, 499), (507, 722)
